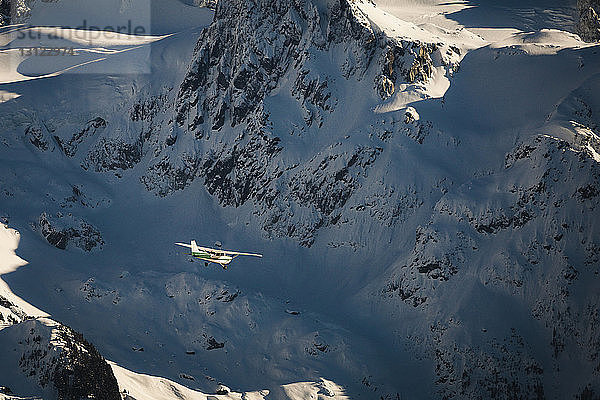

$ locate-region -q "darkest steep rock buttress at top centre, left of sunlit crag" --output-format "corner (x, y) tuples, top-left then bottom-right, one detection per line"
(176, 1), (340, 131)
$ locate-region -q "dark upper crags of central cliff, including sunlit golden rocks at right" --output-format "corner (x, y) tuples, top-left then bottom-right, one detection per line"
(176, 0), (450, 137)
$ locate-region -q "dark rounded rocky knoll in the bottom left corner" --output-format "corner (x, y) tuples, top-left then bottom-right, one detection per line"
(0, 262), (121, 400)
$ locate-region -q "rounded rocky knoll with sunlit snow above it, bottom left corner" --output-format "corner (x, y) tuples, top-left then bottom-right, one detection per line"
(0, 224), (121, 400)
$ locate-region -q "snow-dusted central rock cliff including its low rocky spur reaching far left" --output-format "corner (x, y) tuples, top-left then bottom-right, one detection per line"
(8, 0), (454, 248)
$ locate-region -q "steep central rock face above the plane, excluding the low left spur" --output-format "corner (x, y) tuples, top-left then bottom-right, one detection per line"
(134, 1), (460, 246)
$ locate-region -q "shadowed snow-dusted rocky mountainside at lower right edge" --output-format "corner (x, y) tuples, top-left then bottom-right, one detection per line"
(382, 132), (600, 398)
